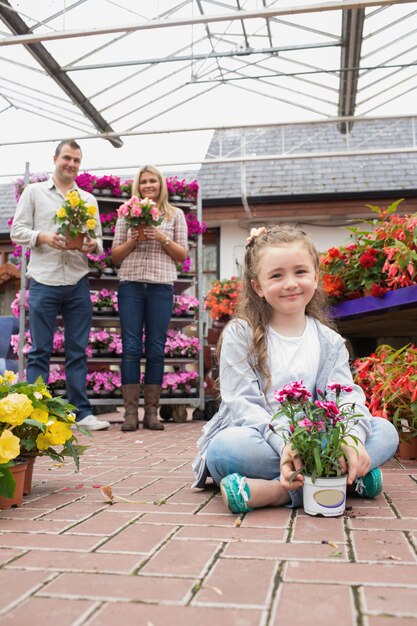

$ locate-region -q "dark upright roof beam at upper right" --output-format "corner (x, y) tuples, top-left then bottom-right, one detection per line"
(338, 3), (365, 133)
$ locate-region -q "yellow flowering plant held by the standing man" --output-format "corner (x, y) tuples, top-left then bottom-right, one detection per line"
(53, 189), (97, 239)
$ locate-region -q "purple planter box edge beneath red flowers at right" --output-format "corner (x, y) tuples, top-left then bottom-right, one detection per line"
(331, 285), (417, 319)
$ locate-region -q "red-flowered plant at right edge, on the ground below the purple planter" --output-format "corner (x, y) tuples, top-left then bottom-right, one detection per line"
(354, 344), (417, 441)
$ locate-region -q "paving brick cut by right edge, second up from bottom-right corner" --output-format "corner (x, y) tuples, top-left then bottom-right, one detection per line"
(362, 586), (417, 618)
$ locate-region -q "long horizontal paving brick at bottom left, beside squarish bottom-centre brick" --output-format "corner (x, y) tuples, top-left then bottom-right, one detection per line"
(38, 572), (195, 604)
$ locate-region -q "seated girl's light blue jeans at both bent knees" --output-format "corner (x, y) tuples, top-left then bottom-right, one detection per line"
(206, 417), (398, 506)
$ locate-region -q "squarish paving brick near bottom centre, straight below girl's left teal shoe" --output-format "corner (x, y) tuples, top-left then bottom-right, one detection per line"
(194, 559), (277, 608)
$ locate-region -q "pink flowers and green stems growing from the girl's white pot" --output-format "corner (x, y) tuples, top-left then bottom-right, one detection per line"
(270, 381), (360, 482)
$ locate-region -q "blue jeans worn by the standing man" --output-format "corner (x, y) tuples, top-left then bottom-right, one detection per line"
(26, 276), (92, 421)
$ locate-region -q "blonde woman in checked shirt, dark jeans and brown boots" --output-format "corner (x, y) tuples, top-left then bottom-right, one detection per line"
(112, 165), (188, 431)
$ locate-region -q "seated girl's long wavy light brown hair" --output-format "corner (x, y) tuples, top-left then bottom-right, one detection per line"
(235, 226), (335, 389)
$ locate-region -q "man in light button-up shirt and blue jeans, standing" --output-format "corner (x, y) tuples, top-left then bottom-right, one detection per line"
(11, 139), (110, 430)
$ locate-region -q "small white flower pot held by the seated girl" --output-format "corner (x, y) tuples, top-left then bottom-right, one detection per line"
(303, 475), (347, 517)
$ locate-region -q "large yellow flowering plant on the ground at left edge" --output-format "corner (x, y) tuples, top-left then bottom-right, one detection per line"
(0, 371), (91, 498)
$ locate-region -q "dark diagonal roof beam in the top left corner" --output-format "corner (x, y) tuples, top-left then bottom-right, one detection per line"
(0, 0), (123, 148)
